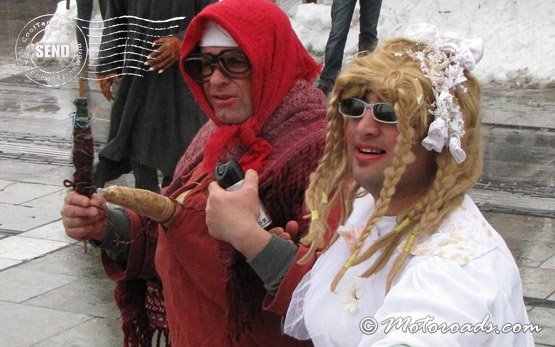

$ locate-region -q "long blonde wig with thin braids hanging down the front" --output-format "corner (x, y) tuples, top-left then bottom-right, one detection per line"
(300, 38), (482, 291)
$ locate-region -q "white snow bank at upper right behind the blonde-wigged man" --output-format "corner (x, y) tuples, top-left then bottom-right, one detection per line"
(284, 0), (555, 88)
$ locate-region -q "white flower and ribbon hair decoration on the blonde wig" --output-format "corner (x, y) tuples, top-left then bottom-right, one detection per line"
(405, 23), (483, 164)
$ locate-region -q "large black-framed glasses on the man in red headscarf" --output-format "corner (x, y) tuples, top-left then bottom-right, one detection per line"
(183, 49), (251, 83)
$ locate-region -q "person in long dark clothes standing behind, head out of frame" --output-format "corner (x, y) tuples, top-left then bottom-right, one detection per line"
(95, 0), (213, 192)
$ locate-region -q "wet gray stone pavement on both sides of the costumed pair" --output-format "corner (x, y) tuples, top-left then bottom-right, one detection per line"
(0, 0), (555, 347)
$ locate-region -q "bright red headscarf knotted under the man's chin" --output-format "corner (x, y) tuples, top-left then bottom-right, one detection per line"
(180, 0), (321, 172)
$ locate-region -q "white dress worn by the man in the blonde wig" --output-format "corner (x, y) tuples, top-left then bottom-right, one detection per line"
(284, 196), (534, 347)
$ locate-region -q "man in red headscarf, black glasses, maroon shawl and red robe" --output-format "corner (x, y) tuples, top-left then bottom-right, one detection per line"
(62, 0), (326, 347)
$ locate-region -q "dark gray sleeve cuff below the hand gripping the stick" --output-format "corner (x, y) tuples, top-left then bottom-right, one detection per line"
(90, 207), (131, 263)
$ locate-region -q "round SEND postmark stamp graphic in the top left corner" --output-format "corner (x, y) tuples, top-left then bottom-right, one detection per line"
(15, 14), (87, 87)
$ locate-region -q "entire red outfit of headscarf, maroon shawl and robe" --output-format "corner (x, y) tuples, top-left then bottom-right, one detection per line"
(104, 0), (326, 347)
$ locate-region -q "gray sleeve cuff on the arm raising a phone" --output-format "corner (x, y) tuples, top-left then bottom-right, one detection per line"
(247, 235), (298, 295)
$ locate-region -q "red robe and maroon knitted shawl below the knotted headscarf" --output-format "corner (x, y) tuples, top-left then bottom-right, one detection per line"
(103, 81), (325, 347)
